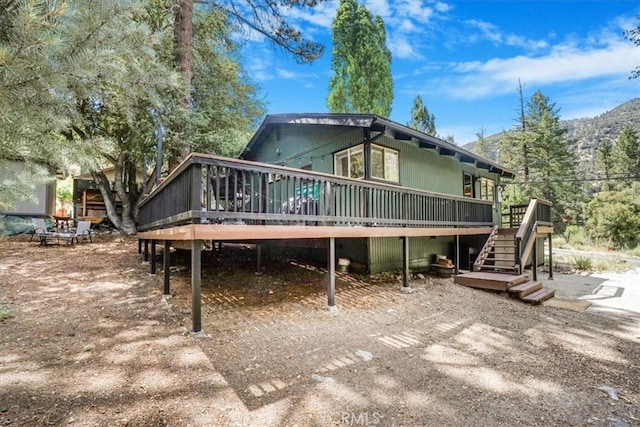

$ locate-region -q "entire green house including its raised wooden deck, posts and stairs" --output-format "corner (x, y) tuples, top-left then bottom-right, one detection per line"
(138, 114), (553, 332)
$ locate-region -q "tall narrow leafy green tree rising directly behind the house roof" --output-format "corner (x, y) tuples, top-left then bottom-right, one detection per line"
(327, 0), (393, 117)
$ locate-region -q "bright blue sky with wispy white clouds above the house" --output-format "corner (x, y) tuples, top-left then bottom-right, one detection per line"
(243, 0), (640, 145)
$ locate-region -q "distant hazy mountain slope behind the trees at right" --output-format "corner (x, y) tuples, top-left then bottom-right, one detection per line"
(464, 98), (640, 174)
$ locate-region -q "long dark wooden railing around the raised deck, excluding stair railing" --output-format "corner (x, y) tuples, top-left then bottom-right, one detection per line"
(139, 154), (493, 231)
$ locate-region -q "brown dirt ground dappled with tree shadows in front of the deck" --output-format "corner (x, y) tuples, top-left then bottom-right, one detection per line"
(0, 236), (640, 427)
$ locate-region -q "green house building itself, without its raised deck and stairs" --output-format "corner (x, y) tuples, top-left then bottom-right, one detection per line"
(241, 114), (514, 273)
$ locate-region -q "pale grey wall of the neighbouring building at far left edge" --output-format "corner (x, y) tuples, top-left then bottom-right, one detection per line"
(0, 160), (56, 216)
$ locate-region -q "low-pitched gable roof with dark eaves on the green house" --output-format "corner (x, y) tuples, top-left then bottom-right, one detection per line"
(245, 113), (515, 179)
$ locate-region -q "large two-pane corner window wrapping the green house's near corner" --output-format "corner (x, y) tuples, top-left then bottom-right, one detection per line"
(335, 145), (400, 182)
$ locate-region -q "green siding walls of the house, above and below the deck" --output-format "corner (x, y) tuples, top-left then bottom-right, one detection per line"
(243, 124), (501, 274)
